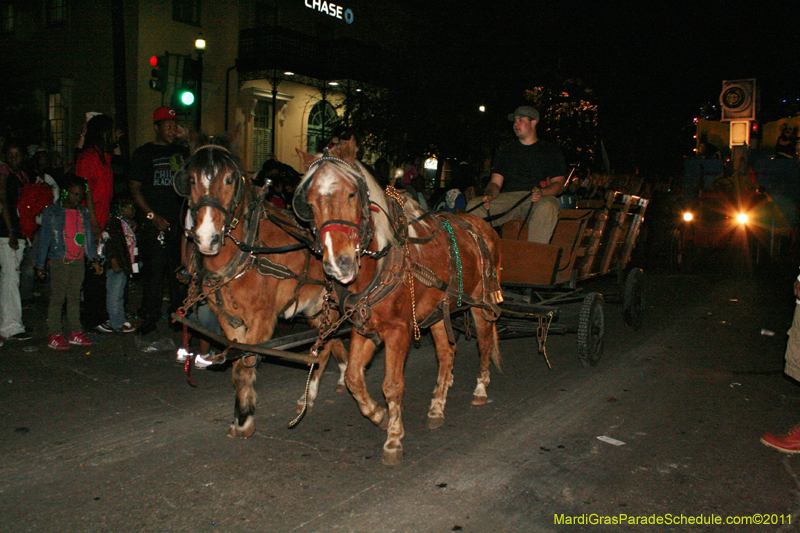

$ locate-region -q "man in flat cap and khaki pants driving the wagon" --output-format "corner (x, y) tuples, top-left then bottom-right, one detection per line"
(467, 106), (567, 244)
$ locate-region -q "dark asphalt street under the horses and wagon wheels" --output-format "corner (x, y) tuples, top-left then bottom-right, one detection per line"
(0, 254), (800, 533)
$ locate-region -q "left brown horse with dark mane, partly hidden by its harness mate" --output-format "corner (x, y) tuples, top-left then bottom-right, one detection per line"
(180, 142), (347, 438)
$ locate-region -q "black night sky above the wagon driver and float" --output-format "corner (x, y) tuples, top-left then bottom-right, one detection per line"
(414, 0), (800, 174)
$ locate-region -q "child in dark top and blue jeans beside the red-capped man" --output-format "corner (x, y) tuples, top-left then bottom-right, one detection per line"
(97, 196), (139, 333)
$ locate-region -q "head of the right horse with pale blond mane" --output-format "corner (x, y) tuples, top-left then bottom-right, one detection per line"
(292, 143), (392, 285)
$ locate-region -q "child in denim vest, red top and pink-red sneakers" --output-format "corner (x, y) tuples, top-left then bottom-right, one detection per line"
(35, 178), (103, 350)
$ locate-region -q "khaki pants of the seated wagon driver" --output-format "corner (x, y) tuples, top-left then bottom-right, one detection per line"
(467, 191), (559, 244)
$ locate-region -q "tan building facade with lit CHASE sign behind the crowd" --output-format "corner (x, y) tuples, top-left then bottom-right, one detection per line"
(0, 0), (412, 172)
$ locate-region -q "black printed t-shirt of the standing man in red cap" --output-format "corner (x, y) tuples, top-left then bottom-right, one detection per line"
(130, 143), (189, 223)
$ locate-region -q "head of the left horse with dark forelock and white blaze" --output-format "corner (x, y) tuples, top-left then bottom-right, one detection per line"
(174, 137), (247, 255)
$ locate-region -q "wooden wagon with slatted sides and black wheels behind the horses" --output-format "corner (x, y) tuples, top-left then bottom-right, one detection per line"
(500, 191), (648, 366)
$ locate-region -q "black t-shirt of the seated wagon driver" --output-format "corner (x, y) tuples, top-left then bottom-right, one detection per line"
(492, 139), (567, 192)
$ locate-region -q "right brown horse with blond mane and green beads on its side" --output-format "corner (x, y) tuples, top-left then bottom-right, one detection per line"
(293, 147), (502, 465)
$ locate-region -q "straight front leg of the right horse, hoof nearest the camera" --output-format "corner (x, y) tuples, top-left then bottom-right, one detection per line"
(383, 328), (411, 466)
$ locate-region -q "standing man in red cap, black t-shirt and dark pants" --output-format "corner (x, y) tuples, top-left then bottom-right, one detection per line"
(130, 107), (189, 334)
